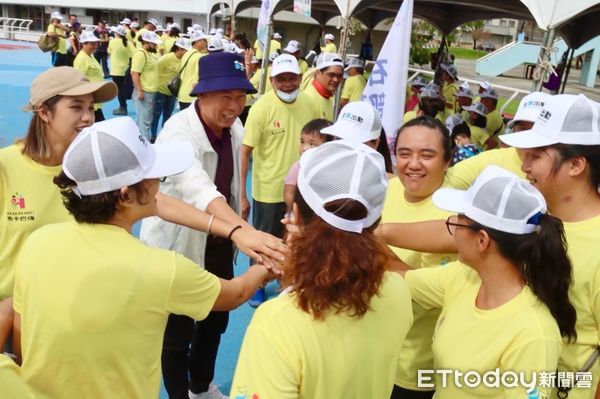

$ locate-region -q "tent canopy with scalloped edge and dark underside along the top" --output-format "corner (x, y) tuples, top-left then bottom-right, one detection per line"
(210, 0), (600, 48)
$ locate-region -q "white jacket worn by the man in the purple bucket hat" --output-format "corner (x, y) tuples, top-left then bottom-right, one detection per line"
(140, 101), (244, 266)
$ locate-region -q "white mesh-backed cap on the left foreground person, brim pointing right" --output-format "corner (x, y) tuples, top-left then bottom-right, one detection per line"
(62, 116), (194, 195)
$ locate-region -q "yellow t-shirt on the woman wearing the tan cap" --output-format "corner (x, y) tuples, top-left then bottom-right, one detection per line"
(0, 144), (71, 299)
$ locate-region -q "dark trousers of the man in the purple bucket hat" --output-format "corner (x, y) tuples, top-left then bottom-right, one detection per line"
(162, 236), (233, 399)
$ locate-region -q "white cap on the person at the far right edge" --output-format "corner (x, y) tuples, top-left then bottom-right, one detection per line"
(499, 94), (600, 148)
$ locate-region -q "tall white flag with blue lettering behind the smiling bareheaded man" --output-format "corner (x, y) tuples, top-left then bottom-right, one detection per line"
(361, 0), (413, 152)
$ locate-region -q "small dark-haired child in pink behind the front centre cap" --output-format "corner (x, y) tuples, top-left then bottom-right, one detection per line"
(283, 119), (333, 214)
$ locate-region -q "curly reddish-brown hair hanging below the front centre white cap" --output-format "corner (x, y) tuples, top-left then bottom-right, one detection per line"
(282, 190), (388, 320)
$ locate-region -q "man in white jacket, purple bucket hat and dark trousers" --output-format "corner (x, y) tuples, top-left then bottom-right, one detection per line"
(141, 53), (268, 399)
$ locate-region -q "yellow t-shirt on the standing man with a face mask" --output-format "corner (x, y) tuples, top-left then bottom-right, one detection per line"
(243, 91), (319, 203)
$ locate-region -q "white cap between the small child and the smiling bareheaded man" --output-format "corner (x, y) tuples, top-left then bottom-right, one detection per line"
(321, 101), (382, 143)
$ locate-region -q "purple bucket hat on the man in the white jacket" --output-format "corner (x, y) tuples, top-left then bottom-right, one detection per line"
(190, 53), (256, 96)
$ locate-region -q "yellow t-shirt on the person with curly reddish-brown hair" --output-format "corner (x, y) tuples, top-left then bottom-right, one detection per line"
(229, 272), (412, 399)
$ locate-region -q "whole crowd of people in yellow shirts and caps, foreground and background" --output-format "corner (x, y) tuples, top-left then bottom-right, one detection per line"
(0, 10), (600, 399)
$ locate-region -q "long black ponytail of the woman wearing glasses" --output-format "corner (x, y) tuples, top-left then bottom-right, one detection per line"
(474, 214), (577, 341)
